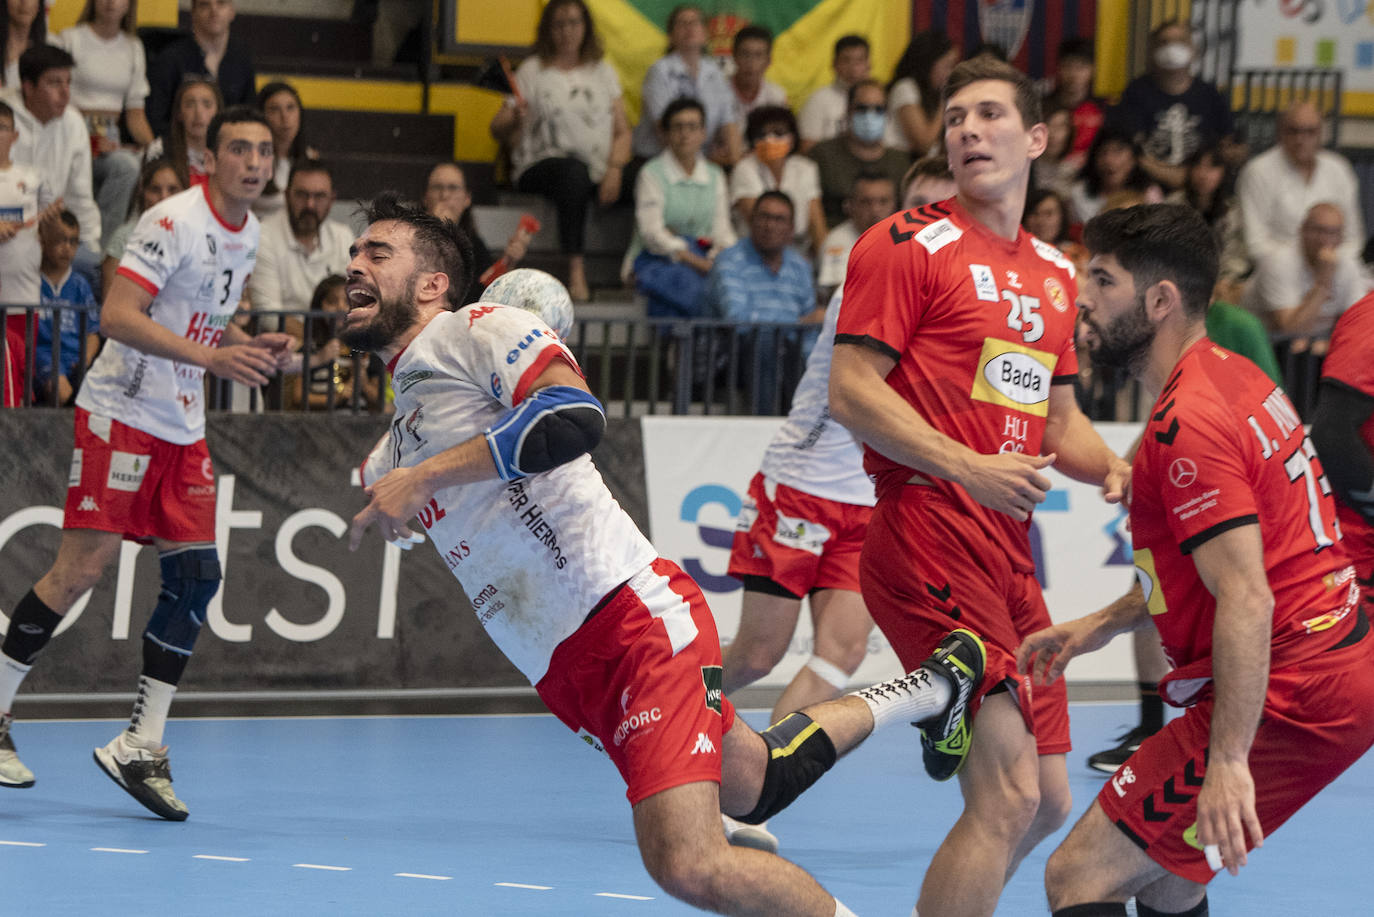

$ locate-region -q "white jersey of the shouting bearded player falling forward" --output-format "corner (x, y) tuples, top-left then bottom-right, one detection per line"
(361, 302), (658, 683)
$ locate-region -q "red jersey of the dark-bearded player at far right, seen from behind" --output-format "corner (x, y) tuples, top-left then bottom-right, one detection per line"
(1131, 338), (1358, 700)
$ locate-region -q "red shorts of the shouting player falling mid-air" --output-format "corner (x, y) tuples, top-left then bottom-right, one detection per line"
(534, 558), (735, 806)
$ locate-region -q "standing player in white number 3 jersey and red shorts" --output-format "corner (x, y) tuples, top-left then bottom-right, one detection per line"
(0, 106), (290, 821)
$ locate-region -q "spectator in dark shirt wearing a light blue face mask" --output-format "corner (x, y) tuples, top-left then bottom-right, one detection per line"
(807, 80), (911, 228)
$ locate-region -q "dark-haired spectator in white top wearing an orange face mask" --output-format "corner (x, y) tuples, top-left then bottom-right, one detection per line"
(730, 106), (826, 257)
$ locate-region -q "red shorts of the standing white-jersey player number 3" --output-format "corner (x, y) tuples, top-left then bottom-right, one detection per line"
(62, 407), (214, 543)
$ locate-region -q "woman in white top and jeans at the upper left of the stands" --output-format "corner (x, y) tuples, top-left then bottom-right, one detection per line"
(54, 0), (153, 248)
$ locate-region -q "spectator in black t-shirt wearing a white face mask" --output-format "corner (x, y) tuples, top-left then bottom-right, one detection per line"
(1109, 19), (1246, 188)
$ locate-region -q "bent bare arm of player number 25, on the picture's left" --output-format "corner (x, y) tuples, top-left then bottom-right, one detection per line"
(830, 342), (1054, 520)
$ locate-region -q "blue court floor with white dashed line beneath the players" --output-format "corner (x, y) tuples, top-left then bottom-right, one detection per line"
(0, 704), (1374, 917)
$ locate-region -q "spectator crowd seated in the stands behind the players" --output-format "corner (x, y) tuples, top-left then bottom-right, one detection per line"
(0, 0), (1370, 415)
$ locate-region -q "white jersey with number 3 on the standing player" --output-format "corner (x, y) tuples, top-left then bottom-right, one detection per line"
(77, 186), (258, 445)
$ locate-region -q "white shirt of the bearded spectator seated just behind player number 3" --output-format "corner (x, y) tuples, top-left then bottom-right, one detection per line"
(249, 209), (353, 312)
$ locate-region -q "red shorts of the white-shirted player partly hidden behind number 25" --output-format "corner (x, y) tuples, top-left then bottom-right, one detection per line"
(730, 472), (872, 597)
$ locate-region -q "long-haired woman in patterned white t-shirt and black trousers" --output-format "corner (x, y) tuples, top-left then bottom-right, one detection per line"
(492, 0), (631, 302)
